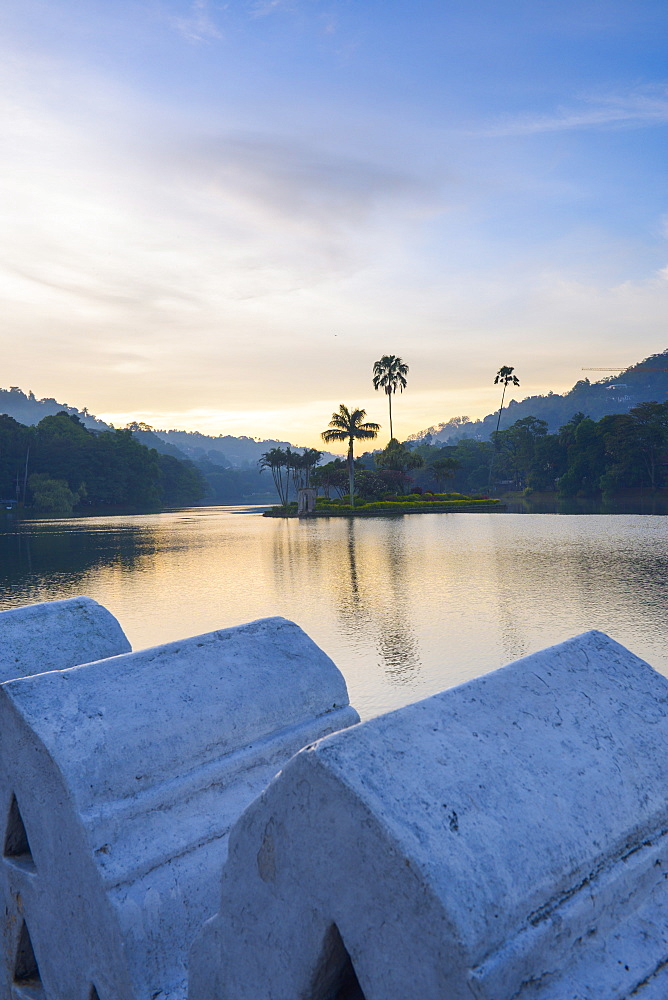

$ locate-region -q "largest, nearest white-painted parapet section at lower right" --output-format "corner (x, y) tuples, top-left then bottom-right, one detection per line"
(189, 632), (668, 1000)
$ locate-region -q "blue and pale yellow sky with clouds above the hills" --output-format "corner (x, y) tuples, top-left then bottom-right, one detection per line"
(0, 0), (668, 446)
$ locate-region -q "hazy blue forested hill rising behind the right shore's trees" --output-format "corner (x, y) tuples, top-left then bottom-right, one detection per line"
(409, 349), (668, 444)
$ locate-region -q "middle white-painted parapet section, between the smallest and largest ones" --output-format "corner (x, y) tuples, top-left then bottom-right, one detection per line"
(0, 618), (357, 1000)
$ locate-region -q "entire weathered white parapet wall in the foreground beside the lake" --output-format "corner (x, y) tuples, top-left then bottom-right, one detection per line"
(5, 598), (668, 1000)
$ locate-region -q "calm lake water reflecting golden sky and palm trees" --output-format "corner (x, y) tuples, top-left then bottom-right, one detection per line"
(0, 507), (668, 717)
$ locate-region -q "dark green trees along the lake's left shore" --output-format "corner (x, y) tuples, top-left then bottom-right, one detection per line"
(0, 412), (206, 513)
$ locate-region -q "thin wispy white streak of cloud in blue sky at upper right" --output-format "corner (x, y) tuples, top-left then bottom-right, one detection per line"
(479, 88), (668, 136)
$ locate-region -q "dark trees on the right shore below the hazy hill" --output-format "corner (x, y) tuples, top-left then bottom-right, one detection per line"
(404, 402), (668, 496)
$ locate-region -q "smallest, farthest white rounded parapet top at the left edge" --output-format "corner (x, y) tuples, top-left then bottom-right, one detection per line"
(0, 597), (130, 681)
